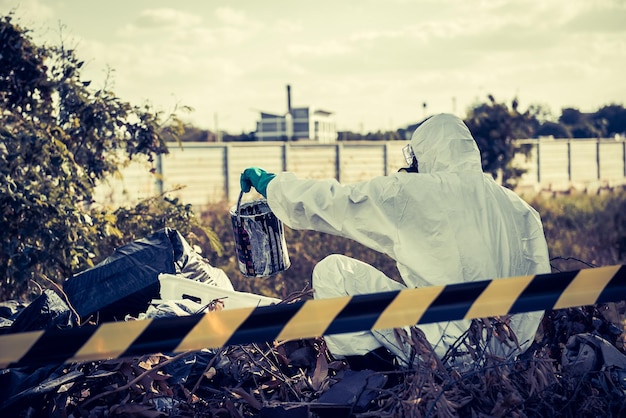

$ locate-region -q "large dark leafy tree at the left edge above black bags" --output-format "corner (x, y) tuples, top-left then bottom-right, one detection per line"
(0, 15), (217, 299)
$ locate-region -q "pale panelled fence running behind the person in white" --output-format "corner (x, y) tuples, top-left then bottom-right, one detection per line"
(96, 139), (626, 206)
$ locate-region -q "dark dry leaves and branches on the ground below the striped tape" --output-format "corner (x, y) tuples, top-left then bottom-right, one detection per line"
(0, 309), (626, 418)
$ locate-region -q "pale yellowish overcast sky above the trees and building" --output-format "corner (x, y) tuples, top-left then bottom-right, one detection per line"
(0, 0), (626, 134)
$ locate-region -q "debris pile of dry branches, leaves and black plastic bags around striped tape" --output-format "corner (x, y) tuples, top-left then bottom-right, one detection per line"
(0, 230), (626, 418)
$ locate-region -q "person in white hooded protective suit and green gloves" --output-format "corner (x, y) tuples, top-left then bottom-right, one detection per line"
(241, 114), (550, 366)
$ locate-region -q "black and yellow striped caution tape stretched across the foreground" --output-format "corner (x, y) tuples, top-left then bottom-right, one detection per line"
(0, 265), (626, 368)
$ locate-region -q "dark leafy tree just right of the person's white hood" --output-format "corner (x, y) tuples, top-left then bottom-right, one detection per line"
(465, 95), (543, 187)
